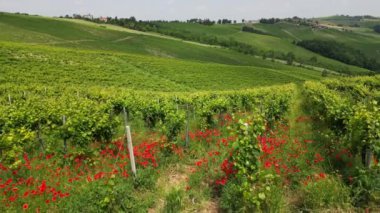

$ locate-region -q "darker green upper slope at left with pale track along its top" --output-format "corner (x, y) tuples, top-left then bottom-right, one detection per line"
(0, 13), (290, 66)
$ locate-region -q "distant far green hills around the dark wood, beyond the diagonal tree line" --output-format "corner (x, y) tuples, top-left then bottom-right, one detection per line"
(144, 22), (379, 73)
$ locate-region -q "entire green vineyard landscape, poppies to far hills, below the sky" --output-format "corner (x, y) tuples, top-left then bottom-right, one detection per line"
(0, 12), (380, 213)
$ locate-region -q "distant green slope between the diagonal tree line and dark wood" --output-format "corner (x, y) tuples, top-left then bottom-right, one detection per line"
(152, 23), (367, 72)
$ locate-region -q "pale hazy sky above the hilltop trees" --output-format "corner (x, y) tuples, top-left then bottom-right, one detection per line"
(0, 0), (380, 20)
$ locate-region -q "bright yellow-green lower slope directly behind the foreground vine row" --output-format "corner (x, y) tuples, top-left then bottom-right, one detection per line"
(0, 43), (321, 91)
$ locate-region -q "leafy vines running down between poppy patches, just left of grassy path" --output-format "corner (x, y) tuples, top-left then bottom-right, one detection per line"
(226, 89), (294, 212)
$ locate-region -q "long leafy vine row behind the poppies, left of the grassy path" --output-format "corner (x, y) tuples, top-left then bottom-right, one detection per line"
(0, 85), (295, 167)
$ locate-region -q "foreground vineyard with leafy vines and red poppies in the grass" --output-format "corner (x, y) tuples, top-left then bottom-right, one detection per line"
(0, 76), (380, 212)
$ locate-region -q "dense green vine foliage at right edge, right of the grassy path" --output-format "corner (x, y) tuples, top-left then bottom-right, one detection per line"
(305, 77), (380, 166)
